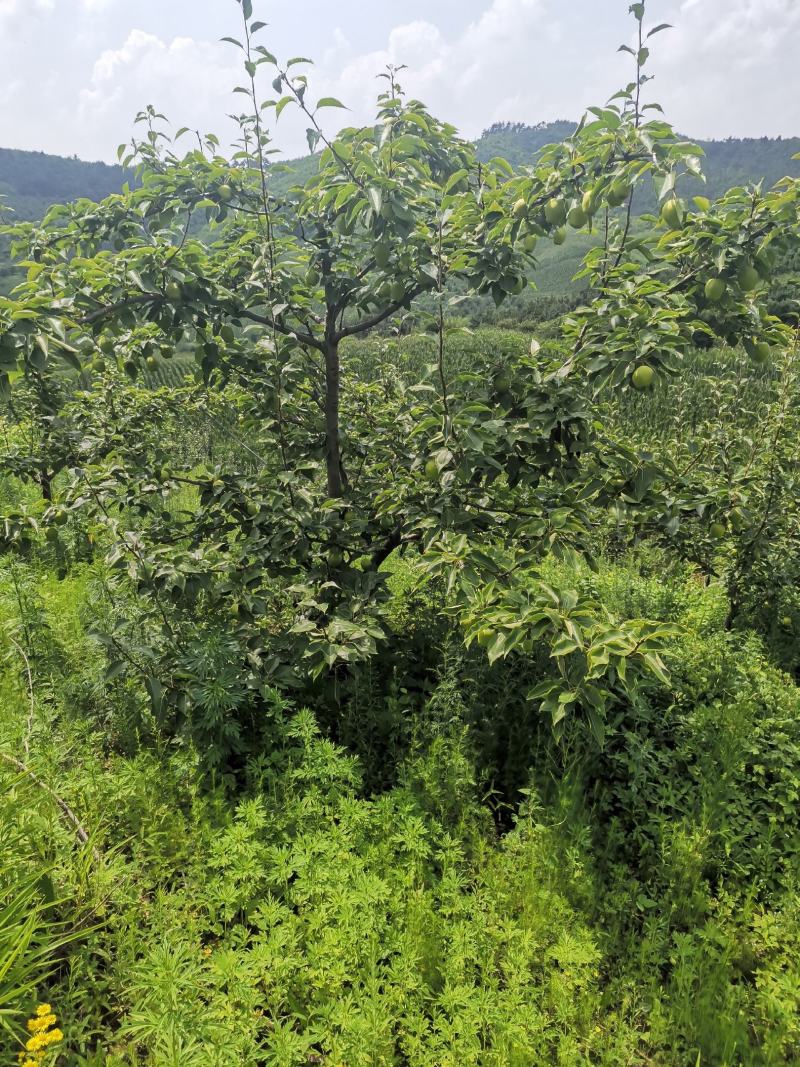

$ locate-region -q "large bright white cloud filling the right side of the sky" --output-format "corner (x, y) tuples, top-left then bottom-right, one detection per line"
(290, 0), (800, 153)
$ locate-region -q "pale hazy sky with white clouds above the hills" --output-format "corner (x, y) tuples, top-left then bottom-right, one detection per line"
(0, 0), (800, 160)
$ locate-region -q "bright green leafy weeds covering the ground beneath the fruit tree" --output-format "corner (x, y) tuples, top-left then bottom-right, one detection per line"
(0, 537), (800, 1065)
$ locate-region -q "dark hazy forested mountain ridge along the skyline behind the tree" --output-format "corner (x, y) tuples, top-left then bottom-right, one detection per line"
(0, 120), (800, 293)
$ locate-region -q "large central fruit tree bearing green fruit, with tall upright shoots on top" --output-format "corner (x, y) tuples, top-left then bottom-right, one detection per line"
(0, 0), (799, 747)
